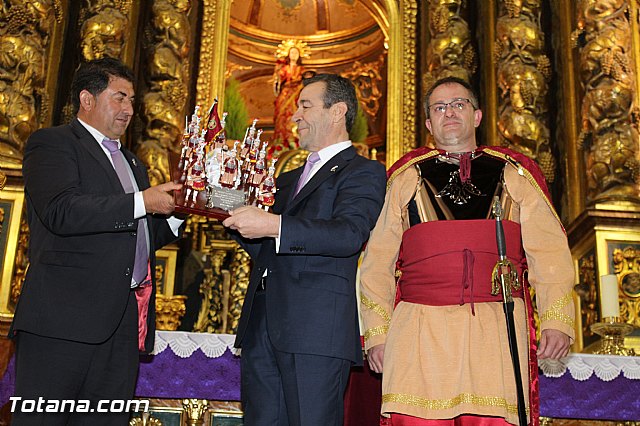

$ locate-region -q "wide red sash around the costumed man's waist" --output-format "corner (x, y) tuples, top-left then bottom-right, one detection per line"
(397, 220), (527, 309)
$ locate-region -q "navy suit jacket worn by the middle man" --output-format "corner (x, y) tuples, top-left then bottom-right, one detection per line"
(236, 147), (386, 363)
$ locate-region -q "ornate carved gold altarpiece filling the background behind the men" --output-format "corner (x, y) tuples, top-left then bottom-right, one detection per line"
(0, 0), (640, 424)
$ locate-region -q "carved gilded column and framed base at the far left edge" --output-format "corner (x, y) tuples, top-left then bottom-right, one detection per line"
(0, 0), (67, 334)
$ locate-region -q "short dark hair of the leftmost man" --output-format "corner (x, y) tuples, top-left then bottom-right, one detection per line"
(71, 57), (133, 113)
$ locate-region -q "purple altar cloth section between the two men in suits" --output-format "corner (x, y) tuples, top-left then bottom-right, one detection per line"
(136, 348), (240, 401)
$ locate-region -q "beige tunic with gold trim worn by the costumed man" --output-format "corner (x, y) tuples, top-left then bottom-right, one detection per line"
(360, 163), (574, 424)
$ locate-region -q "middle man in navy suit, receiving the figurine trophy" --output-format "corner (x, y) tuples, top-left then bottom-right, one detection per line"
(223, 74), (385, 426)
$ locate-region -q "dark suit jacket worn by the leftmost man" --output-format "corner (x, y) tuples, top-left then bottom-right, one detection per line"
(10, 120), (176, 351)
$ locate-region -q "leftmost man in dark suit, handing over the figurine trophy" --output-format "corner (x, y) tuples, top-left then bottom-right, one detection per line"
(10, 58), (182, 425)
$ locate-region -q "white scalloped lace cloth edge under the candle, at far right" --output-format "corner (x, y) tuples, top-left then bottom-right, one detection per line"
(538, 353), (640, 382)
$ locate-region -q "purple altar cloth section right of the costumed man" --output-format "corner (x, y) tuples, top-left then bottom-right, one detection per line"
(540, 371), (640, 421)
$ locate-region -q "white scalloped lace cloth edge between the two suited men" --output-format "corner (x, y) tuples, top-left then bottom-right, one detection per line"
(151, 331), (240, 358)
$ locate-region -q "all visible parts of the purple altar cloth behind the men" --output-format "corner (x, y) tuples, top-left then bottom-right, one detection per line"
(0, 348), (640, 421)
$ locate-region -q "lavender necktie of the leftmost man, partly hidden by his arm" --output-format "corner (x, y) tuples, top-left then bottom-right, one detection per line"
(102, 138), (149, 284)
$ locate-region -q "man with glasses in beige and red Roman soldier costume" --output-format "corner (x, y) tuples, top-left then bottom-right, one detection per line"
(361, 77), (574, 426)
